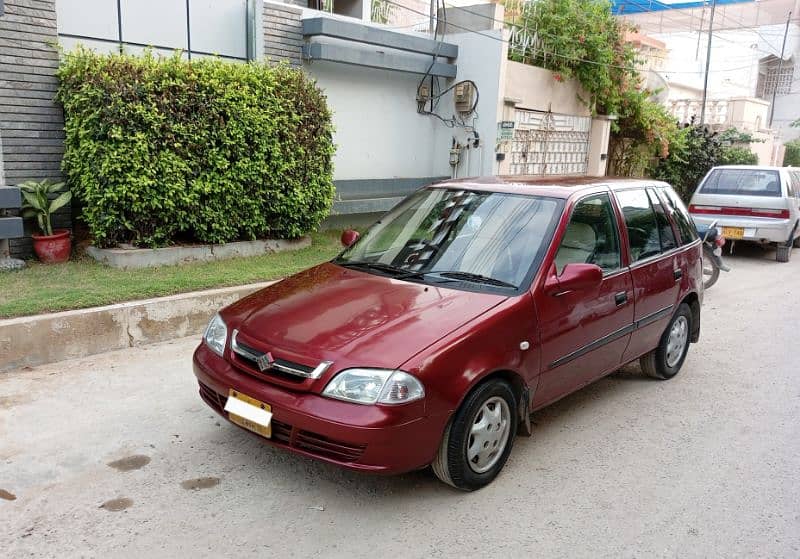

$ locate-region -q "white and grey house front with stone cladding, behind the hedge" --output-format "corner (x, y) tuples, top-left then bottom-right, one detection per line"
(0, 0), (610, 255)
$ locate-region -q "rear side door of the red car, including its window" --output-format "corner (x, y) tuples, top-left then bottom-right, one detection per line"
(614, 188), (684, 362)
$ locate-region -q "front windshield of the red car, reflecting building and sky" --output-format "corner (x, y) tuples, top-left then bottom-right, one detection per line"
(335, 188), (561, 289)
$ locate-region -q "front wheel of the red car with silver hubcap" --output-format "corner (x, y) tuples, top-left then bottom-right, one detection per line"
(431, 379), (518, 491)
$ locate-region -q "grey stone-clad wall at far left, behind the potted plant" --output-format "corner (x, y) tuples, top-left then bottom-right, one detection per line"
(0, 0), (71, 257)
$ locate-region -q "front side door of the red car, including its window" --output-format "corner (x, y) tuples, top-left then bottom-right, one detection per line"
(533, 192), (633, 407)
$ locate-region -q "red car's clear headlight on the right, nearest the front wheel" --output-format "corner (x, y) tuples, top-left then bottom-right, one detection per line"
(322, 369), (425, 404)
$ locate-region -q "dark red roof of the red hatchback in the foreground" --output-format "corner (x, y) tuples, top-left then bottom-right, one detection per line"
(431, 175), (669, 198)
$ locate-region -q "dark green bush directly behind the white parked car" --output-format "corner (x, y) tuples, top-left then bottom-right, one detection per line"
(649, 125), (758, 202)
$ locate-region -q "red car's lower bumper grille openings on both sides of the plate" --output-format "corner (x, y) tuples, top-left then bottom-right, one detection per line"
(200, 382), (367, 462)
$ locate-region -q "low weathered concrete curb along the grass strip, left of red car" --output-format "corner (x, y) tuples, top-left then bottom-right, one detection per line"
(0, 281), (275, 373)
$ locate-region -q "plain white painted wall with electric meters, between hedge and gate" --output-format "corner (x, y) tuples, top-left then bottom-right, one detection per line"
(304, 25), (504, 180)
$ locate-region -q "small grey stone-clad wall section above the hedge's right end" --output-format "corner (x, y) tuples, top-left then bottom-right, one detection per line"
(264, 2), (303, 66)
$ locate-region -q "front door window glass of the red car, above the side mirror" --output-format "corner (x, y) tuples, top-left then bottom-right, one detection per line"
(556, 194), (622, 275)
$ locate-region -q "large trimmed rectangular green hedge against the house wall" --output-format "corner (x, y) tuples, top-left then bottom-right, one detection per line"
(58, 49), (334, 247)
